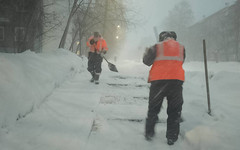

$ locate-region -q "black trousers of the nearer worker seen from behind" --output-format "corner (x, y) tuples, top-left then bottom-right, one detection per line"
(146, 80), (183, 140)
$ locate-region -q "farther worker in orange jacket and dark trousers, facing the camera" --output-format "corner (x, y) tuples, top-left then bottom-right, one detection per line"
(87, 32), (108, 84)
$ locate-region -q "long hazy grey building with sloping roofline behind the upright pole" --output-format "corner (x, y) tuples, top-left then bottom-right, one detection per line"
(184, 1), (240, 61)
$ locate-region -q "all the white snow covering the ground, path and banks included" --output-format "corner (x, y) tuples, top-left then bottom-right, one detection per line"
(0, 49), (240, 150)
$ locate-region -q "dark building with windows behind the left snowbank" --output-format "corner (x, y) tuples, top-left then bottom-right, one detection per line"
(0, 0), (43, 53)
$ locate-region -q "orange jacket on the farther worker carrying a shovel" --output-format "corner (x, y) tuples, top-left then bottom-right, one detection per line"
(87, 36), (108, 53)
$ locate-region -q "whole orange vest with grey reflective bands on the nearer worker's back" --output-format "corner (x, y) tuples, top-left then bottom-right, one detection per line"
(148, 39), (185, 82)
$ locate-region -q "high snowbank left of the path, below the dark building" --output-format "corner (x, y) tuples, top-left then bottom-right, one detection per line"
(0, 49), (85, 128)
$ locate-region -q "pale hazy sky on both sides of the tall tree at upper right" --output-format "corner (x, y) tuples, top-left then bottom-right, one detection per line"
(122, 0), (236, 57)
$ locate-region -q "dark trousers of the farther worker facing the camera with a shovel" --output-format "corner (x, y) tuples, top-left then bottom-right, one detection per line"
(87, 52), (103, 76)
